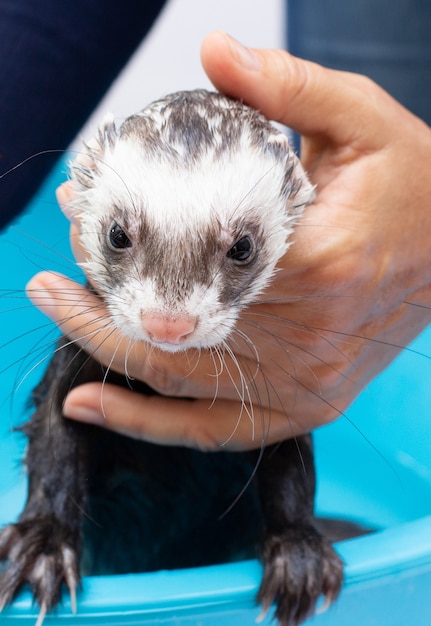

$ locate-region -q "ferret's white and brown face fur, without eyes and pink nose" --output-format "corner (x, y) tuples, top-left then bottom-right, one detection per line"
(72, 91), (313, 350)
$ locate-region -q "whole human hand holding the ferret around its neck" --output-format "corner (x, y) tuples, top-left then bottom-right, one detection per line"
(29, 33), (431, 449)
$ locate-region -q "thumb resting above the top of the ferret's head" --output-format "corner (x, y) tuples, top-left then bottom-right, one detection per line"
(201, 32), (404, 146)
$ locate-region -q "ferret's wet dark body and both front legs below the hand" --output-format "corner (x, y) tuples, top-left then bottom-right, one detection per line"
(0, 330), (342, 626)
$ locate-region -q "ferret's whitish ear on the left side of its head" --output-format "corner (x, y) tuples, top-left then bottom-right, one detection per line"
(70, 113), (117, 189)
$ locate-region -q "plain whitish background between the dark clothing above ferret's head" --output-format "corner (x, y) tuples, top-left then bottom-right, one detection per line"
(75, 0), (285, 145)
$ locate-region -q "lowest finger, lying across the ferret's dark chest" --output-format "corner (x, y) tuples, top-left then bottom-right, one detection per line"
(63, 383), (299, 451)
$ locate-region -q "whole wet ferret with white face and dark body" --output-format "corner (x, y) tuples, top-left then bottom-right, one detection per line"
(0, 90), (343, 626)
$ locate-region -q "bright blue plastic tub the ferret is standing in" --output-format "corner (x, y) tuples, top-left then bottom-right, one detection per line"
(0, 160), (431, 626)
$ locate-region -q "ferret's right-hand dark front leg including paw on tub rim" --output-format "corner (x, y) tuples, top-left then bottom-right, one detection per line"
(257, 436), (343, 626)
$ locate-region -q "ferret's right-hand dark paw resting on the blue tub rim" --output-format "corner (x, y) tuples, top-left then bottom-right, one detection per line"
(258, 526), (343, 626)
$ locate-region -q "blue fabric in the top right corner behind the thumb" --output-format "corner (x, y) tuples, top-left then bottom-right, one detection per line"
(287, 0), (431, 124)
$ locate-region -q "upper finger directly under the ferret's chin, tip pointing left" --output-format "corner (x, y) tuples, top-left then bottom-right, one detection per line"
(27, 272), (256, 399)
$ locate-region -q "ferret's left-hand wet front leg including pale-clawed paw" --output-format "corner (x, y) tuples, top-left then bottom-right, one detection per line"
(0, 342), (94, 623)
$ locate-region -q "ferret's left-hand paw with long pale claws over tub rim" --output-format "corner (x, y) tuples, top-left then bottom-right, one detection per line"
(0, 517), (80, 626)
